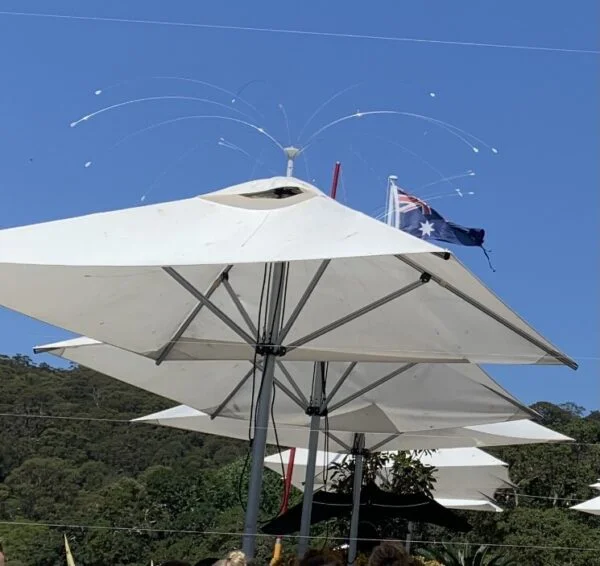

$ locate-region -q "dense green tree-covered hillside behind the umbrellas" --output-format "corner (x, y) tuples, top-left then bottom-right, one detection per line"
(0, 356), (600, 566)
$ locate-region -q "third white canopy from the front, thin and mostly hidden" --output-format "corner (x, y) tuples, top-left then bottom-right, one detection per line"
(135, 405), (572, 454)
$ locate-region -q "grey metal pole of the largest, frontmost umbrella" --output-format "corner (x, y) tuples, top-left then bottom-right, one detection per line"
(242, 263), (285, 558)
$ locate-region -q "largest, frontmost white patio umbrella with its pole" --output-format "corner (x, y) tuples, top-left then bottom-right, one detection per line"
(0, 177), (576, 556)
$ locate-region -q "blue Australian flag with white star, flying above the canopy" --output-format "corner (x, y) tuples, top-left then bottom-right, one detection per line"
(392, 186), (485, 248)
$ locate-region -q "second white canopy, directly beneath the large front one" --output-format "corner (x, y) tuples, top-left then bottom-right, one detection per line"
(44, 338), (533, 434)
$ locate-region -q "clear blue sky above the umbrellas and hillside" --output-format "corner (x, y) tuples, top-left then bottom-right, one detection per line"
(0, 0), (600, 409)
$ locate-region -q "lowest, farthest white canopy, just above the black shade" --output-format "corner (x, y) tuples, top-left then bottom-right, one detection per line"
(265, 448), (512, 510)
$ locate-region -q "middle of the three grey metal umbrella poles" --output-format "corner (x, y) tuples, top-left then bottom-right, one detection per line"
(298, 362), (325, 557)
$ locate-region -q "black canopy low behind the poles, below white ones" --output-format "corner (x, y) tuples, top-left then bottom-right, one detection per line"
(262, 485), (471, 535)
